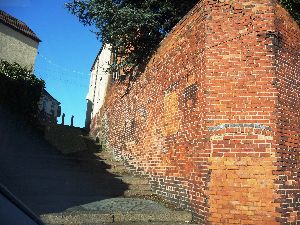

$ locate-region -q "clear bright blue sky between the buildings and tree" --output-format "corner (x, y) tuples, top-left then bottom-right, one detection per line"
(0, 0), (101, 127)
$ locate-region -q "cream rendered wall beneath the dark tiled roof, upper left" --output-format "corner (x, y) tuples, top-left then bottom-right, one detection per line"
(0, 23), (39, 69)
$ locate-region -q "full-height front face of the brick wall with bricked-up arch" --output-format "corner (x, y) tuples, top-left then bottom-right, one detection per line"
(205, 0), (278, 224)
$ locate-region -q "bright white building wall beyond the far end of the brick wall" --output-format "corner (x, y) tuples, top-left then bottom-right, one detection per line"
(86, 44), (111, 128)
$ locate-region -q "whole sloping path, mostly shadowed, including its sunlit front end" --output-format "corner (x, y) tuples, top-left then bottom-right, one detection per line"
(0, 111), (197, 225)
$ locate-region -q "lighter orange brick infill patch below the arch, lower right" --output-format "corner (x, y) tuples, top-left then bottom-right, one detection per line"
(207, 157), (279, 224)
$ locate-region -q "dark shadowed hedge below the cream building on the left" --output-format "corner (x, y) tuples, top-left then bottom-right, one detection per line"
(0, 60), (45, 124)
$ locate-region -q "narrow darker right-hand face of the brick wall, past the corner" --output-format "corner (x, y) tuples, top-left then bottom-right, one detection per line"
(273, 3), (300, 224)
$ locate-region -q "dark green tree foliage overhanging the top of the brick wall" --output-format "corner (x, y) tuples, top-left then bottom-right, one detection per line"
(66, 0), (198, 78)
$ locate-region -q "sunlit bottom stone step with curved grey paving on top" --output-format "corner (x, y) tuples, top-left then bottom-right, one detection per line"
(41, 198), (192, 225)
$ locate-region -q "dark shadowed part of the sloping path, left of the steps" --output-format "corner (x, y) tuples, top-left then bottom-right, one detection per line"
(0, 111), (127, 215)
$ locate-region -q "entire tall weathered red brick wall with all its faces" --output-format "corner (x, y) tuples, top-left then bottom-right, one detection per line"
(91, 0), (300, 225)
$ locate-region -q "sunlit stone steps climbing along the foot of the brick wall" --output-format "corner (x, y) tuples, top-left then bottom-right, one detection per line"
(41, 137), (196, 225)
